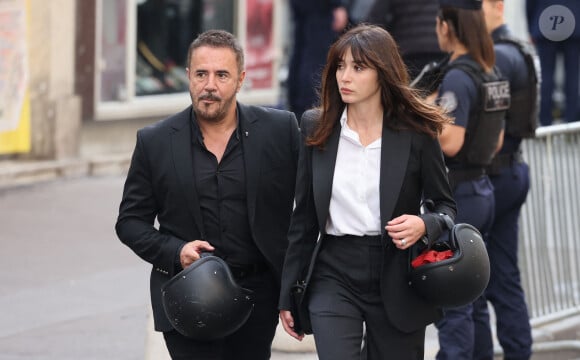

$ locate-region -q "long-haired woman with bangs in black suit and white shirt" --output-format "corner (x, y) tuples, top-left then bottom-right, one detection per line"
(279, 25), (456, 360)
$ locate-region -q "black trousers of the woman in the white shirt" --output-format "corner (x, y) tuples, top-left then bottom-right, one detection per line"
(308, 236), (425, 360)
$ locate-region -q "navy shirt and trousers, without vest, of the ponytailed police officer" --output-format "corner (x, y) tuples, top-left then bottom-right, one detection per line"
(435, 55), (495, 360)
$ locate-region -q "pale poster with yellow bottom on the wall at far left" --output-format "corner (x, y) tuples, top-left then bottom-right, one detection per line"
(0, 0), (30, 154)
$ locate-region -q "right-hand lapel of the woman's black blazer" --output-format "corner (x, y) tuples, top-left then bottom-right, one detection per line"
(379, 126), (411, 235)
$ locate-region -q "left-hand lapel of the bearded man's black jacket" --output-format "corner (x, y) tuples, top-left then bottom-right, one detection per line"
(170, 106), (205, 239)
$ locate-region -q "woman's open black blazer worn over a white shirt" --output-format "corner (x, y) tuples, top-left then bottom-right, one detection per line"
(279, 111), (456, 332)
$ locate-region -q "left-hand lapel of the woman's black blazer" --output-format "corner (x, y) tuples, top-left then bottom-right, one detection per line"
(312, 123), (341, 232)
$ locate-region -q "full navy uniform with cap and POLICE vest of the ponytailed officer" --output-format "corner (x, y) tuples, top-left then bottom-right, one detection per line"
(435, 0), (510, 360)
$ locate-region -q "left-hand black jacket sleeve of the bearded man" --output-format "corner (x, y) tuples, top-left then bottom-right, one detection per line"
(115, 130), (185, 276)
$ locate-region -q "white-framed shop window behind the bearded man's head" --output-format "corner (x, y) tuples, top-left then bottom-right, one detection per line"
(94, 0), (288, 120)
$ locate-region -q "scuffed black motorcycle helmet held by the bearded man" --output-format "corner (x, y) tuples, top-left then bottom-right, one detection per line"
(162, 254), (254, 340)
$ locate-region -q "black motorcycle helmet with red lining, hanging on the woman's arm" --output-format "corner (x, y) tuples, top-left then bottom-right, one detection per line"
(409, 223), (490, 308)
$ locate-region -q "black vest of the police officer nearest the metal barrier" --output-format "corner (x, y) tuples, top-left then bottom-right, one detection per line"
(496, 36), (541, 138)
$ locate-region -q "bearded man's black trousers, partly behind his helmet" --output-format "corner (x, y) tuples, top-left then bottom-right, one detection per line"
(163, 271), (280, 360)
